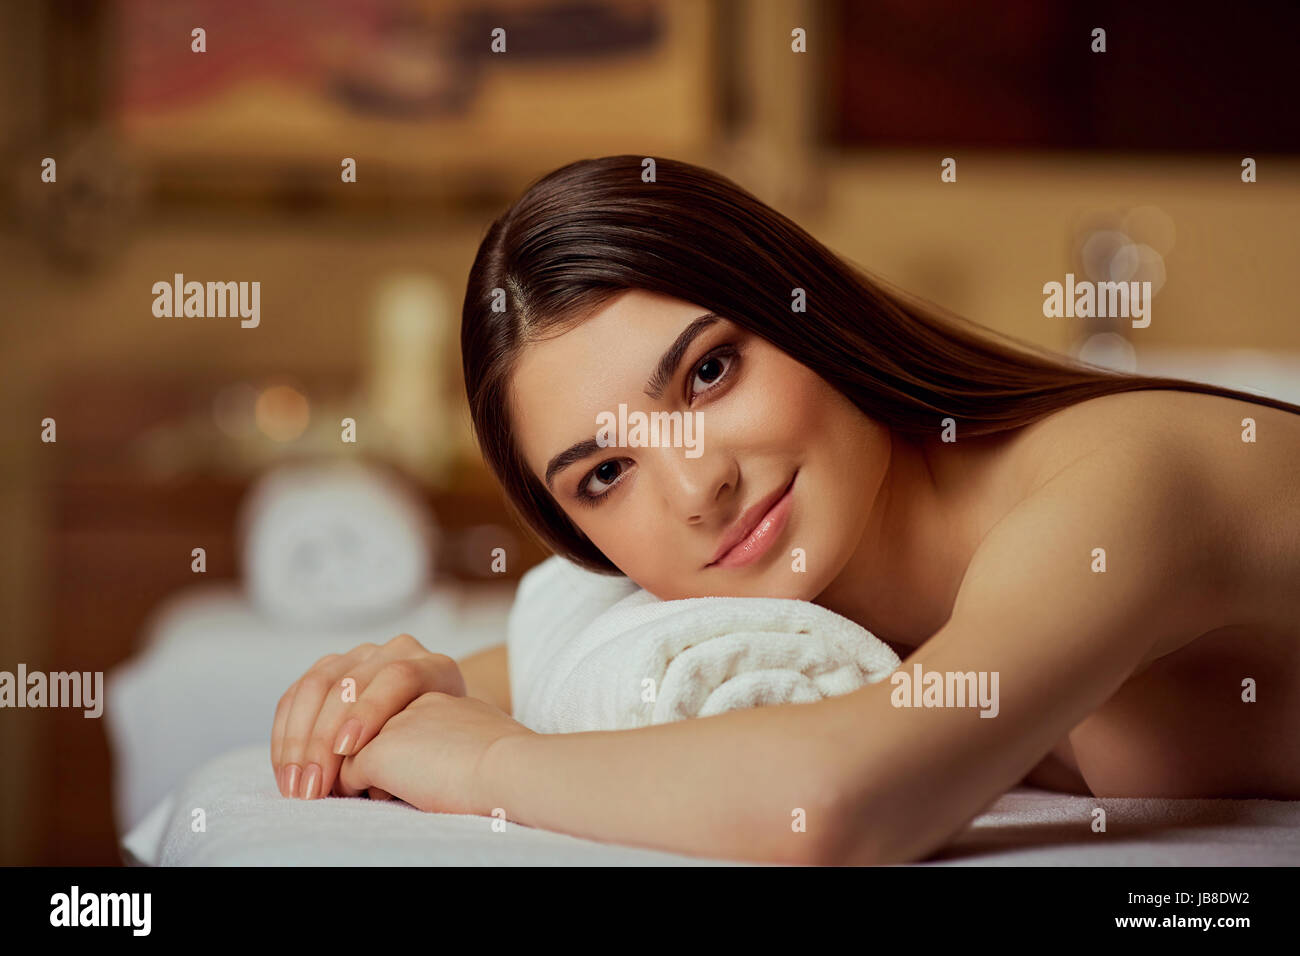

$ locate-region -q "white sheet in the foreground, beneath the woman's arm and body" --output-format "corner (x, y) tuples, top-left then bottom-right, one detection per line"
(124, 745), (1300, 866)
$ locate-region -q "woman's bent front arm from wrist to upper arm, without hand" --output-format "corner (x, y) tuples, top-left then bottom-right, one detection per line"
(482, 449), (1209, 864)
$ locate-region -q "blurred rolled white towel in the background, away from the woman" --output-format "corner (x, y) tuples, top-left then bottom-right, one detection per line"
(239, 462), (438, 627)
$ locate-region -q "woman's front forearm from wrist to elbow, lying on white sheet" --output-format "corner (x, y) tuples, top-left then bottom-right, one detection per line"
(484, 700), (845, 864)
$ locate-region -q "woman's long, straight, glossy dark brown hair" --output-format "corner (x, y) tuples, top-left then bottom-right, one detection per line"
(460, 155), (1300, 574)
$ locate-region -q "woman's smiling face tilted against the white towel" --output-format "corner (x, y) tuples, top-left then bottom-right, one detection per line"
(511, 290), (889, 601)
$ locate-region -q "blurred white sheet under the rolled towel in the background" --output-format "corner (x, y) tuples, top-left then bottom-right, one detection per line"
(104, 583), (514, 832)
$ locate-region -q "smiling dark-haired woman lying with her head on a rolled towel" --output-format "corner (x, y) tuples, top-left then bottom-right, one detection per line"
(272, 156), (1300, 864)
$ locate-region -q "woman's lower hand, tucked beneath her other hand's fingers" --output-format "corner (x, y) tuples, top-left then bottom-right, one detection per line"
(338, 693), (534, 817)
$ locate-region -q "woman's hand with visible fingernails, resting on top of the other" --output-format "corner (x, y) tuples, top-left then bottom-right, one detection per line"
(270, 633), (465, 800)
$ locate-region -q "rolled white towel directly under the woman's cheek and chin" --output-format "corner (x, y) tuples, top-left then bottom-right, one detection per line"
(511, 589), (901, 734)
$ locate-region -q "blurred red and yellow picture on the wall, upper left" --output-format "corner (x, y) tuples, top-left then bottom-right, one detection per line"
(104, 0), (718, 196)
